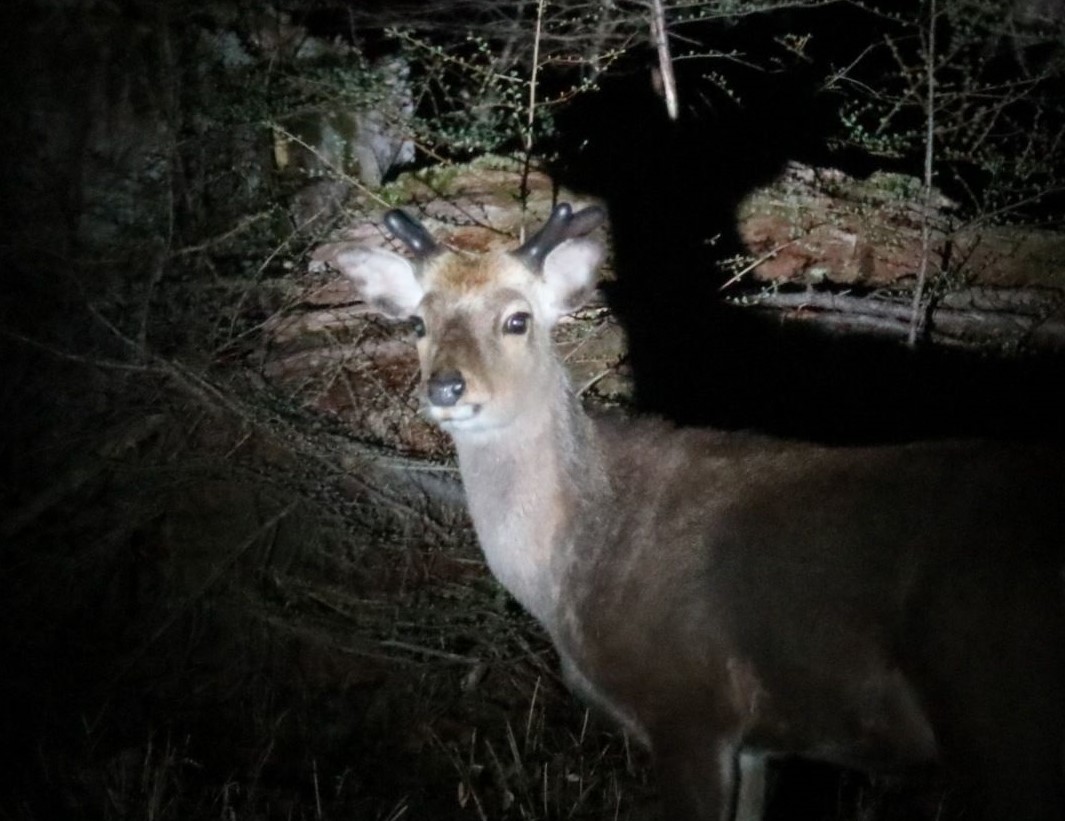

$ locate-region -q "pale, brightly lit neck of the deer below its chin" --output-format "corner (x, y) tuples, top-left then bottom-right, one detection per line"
(455, 365), (607, 630)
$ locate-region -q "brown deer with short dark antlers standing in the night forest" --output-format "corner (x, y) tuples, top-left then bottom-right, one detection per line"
(321, 203), (1065, 821)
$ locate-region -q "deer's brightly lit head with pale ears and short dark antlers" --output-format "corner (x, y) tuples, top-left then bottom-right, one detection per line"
(332, 206), (602, 436)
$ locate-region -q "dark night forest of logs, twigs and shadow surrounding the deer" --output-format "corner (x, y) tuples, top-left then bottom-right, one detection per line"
(0, 0), (1065, 821)
